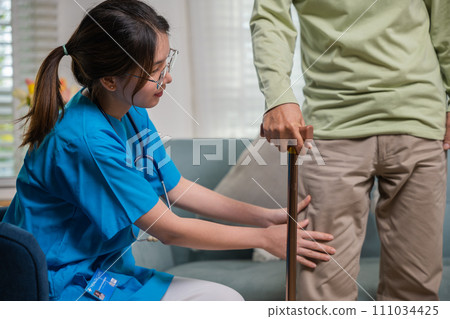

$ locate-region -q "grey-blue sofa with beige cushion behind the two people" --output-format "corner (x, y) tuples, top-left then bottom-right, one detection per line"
(133, 138), (450, 301)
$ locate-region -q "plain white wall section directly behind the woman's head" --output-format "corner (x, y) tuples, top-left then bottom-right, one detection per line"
(58, 0), (193, 138)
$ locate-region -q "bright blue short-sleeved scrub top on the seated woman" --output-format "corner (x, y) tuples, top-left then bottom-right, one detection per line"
(4, 91), (181, 300)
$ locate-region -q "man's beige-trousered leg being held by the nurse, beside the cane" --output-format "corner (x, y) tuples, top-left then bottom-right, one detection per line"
(297, 137), (377, 300)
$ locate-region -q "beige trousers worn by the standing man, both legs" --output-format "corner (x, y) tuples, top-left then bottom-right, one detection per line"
(297, 135), (447, 300)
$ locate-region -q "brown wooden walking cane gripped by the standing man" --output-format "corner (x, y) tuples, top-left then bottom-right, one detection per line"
(260, 124), (314, 301)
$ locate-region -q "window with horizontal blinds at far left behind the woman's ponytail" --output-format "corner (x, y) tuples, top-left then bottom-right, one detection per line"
(0, 0), (58, 182)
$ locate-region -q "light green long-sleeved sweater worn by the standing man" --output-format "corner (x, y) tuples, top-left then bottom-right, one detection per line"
(250, 0), (450, 140)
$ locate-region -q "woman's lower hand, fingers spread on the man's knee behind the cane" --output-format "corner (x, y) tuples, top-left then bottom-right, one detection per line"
(264, 219), (336, 268)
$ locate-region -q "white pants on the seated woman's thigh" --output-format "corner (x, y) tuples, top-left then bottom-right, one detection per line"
(161, 277), (244, 301)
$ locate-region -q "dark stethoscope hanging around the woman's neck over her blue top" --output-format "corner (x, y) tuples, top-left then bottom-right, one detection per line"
(97, 104), (172, 242)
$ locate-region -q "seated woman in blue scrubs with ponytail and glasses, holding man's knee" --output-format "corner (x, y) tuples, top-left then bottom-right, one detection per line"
(5, 0), (334, 300)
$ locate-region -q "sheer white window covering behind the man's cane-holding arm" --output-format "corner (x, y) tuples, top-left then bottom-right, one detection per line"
(187, 0), (304, 138)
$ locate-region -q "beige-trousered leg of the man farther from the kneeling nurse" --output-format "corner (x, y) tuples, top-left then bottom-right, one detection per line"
(376, 135), (447, 300)
